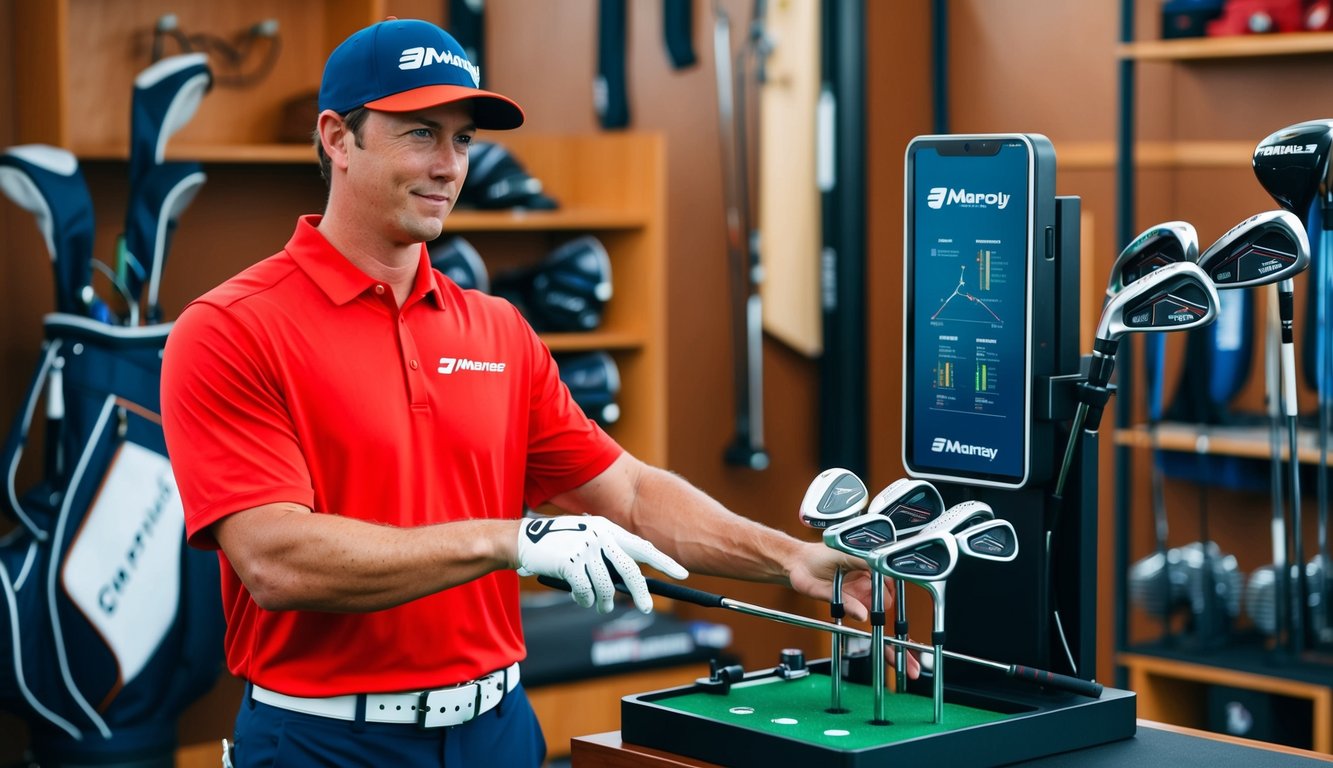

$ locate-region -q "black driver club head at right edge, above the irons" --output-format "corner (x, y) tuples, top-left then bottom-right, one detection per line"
(1252, 120), (1333, 224)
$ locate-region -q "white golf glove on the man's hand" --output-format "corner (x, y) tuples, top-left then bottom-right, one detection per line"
(519, 515), (689, 613)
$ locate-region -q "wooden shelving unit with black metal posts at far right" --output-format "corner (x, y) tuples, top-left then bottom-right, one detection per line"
(1114, 0), (1333, 752)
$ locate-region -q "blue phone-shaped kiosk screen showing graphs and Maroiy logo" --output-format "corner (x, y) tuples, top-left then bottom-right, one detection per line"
(906, 139), (1032, 483)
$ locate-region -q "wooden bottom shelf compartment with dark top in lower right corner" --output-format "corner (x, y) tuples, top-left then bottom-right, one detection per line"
(1116, 644), (1333, 752)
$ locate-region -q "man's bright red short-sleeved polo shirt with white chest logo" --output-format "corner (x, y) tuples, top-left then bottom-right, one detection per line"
(163, 216), (621, 696)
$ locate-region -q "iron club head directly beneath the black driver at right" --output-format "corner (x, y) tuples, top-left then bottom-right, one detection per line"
(1198, 211), (1310, 291)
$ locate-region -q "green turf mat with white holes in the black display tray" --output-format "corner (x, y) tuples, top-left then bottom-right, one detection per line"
(653, 675), (1012, 749)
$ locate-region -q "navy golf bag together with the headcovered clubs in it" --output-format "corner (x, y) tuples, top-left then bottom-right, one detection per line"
(0, 53), (224, 767)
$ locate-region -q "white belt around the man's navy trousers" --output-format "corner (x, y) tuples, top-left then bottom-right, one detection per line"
(251, 661), (519, 728)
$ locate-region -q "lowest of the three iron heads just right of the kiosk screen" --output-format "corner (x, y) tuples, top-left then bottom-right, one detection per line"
(1097, 261), (1217, 353)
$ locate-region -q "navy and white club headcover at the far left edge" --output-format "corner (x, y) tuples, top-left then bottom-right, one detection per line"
(0, 144), (93, 316)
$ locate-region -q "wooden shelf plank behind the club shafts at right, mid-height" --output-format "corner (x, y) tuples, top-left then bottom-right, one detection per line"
(1116, 421), (1320, 464)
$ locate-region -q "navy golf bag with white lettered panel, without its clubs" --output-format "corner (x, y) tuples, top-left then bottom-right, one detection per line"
(0, 313), (224, 765)
